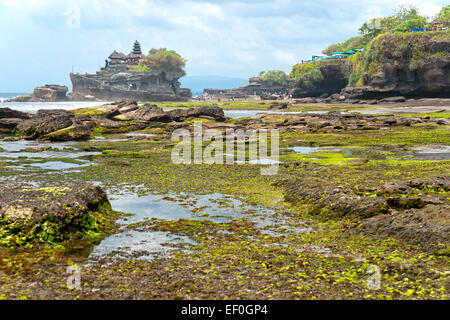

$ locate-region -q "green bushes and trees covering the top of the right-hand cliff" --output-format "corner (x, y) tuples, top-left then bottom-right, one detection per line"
(290, 6), (450, 87)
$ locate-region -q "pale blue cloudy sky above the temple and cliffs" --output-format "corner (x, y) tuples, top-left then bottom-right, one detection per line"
(0, 0), (448, 92)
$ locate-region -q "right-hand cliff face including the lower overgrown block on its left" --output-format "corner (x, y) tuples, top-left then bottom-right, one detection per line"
(291, 30), (450, 100)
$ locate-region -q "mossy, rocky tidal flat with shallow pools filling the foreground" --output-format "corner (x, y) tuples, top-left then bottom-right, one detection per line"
(0, 101), (450, 299)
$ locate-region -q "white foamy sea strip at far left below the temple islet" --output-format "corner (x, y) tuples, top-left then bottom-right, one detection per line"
(0, 92), (108, 113)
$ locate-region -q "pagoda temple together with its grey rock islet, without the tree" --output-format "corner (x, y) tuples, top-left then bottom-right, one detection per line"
(69, 41), (192, 101)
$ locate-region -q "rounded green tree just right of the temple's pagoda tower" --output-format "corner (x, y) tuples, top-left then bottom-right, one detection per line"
(140, 48), (187, 75)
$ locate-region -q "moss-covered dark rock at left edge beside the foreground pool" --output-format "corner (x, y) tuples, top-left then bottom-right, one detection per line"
(0, 185), (113, 245)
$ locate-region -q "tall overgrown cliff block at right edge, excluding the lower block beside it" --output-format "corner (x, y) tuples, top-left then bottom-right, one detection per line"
(342, 31), (450, 99)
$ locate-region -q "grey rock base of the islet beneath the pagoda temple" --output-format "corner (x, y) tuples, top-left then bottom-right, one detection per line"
(69, 70), (191, 101)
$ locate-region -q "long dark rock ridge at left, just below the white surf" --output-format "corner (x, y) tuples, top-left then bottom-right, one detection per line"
(5, 101), (226, 141)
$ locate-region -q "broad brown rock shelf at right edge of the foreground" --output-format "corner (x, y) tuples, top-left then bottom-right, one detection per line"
(279, 172), (450, 250)
